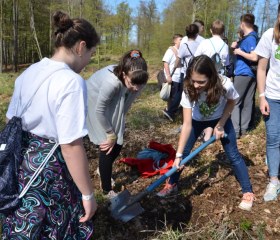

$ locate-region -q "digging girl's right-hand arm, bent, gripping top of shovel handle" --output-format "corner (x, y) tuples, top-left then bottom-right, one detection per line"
(214, 99), (235, 139)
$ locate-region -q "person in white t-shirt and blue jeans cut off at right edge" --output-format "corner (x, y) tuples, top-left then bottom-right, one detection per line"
(254, 4), (280, 201)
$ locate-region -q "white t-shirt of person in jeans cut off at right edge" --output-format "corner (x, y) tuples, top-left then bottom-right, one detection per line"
(254, 28), (280, 100)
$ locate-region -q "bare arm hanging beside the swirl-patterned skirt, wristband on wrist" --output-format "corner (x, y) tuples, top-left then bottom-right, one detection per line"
(61, 138), (97, 222)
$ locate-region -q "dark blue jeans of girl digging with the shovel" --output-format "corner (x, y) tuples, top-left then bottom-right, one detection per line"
(169, 119), (252, 193)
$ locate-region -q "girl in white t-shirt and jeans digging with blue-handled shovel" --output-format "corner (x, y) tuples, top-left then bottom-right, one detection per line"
(157, 55), (254, 210)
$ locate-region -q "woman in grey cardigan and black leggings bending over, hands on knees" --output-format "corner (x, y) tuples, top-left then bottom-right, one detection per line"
(87, 50), (149, 199)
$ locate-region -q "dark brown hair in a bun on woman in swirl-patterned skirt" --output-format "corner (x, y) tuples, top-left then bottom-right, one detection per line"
(53, 11), (100, 49)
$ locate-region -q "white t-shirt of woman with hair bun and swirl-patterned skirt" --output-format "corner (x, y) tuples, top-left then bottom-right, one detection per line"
(6, 58), (88, 144)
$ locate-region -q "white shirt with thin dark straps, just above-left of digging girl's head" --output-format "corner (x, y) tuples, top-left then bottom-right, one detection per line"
(178, 41), (199, 75)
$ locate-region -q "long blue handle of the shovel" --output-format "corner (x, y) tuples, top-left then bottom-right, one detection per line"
(145, 133), (227, 193)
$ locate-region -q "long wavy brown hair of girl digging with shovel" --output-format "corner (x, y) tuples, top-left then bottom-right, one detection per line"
(184, 55), (226, 106)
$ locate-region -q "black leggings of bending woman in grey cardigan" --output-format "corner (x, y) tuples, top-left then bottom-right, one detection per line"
(99, 144), (122, 193)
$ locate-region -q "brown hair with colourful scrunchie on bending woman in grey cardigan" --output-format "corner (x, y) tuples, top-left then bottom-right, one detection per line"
(113, 50), (149, 85)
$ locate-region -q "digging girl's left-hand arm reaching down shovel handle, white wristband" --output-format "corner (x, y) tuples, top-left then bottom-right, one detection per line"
(173, 108), (192, 168)
